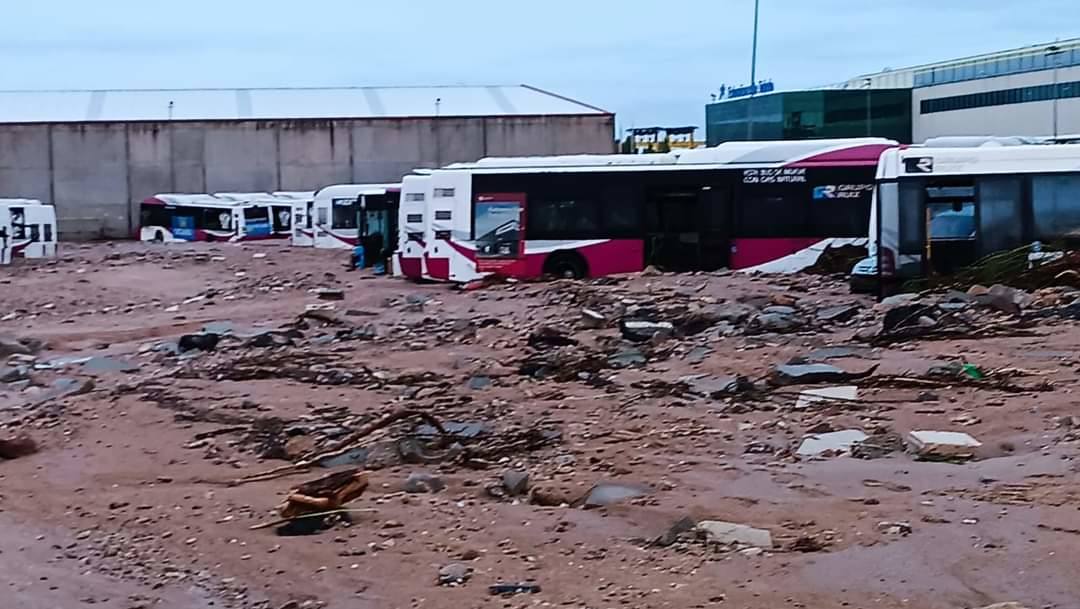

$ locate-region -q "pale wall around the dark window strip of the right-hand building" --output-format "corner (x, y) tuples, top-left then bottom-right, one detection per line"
(912, 67), (1080, 143)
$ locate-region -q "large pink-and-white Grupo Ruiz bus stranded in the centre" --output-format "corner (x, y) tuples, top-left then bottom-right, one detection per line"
(408, 138), (897, 282)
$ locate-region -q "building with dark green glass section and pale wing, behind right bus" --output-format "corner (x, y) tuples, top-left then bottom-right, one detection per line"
(705, 39), (1080, 146)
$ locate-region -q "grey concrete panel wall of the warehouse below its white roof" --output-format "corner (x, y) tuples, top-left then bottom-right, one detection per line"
(0, 116), (615, 239)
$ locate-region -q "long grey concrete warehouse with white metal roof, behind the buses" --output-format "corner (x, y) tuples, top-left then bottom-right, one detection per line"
(0, 85), (616, 239)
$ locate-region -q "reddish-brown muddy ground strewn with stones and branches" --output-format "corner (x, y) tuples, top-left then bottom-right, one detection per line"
(0, 244), (1080, 609)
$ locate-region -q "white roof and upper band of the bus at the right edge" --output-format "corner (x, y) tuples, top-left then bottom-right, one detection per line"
(878, 144), (1080, 179)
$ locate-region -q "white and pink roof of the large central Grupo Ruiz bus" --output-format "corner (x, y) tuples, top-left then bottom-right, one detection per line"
(445, 137), (899, 173)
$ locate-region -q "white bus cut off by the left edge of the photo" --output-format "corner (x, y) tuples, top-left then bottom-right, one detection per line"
(0, 199), (58, 265)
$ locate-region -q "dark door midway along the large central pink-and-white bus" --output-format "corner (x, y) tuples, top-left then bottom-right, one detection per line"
(645, 186), (703, 271)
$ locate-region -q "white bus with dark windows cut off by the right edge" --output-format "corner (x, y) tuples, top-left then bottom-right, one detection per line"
(872, 144), (1080, 285)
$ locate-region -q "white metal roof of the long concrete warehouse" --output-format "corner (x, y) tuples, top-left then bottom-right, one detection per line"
(0, 84), (609, 123)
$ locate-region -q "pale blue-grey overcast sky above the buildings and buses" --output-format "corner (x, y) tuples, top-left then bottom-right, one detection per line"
(0, 0), (1080, 127)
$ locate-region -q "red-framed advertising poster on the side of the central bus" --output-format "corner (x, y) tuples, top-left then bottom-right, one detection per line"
(473, 192), (526, 276)
